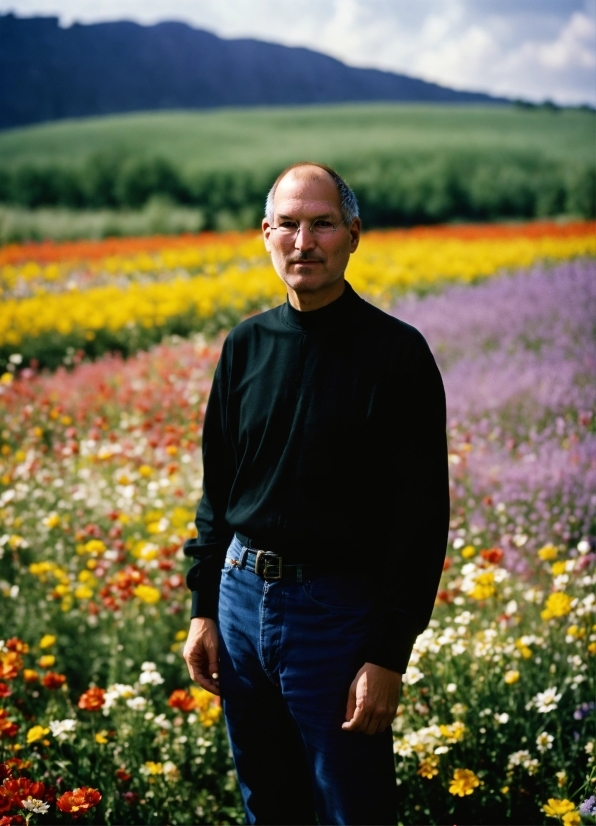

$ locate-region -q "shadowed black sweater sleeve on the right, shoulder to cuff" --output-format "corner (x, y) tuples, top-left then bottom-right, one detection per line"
(367, 330), (449, 673)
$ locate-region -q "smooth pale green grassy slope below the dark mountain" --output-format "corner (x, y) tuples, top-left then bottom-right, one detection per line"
(0, 104), (596, 173)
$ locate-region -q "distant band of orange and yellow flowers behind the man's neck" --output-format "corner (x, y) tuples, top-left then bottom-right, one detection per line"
(0, 222), (596, 367)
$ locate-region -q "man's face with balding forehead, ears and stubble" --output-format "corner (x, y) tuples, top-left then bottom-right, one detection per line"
(263, 166), (360, 304)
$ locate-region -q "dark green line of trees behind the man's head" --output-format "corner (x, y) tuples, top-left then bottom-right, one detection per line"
(0, 150), (596, 229)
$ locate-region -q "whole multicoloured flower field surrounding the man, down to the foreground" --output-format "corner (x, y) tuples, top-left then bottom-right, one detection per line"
(0, 224), (596, 826)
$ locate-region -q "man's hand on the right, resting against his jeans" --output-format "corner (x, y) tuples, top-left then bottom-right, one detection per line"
(342, 663), (401, 734)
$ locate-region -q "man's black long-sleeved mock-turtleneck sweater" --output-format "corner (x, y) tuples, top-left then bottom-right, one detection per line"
(184, 284), (449, 672)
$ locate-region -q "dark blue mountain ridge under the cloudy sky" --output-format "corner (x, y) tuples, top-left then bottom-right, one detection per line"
(0, 14), (503, 128)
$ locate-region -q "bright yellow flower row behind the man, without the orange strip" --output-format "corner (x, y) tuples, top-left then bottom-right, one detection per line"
(0, 227), (596, 347)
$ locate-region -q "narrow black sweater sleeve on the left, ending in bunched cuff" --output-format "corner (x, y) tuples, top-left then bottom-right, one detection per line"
(184, 347), (235, 619)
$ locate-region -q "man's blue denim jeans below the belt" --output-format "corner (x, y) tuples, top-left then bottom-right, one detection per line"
(219, 538), (397, 824)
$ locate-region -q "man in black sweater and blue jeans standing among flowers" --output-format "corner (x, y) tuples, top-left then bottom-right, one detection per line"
(184, 163), (449, 824)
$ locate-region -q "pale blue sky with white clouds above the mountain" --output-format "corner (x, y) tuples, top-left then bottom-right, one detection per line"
(0, 0), (596, 105)
